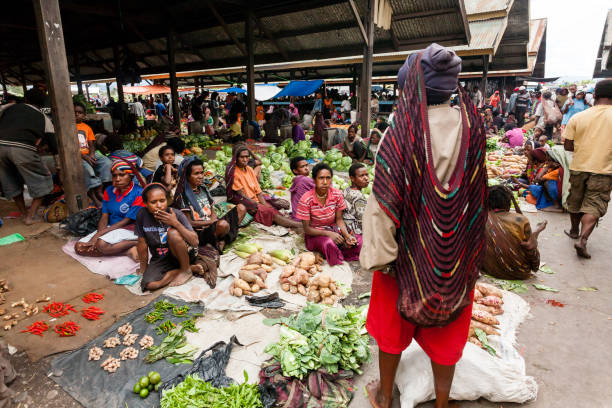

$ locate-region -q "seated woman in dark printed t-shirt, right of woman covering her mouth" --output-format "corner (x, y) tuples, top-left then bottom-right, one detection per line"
(173, 157), (246, 252)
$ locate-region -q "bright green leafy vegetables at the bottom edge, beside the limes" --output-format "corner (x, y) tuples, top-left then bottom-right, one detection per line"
(161, 371), (263, 408)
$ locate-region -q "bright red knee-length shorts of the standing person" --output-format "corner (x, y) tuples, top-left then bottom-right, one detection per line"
(366, 271), (474, 365)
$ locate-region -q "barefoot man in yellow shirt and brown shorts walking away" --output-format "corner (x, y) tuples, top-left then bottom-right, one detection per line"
(563, 79), (612, 259)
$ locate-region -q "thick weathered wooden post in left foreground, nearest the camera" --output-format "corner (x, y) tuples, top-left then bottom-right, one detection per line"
(33, 0), (87, 214)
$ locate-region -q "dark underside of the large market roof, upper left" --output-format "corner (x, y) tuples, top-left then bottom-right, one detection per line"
(0, 0), (470, 84)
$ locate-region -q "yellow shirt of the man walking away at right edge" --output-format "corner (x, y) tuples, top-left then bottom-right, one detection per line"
(563, 105), (612, 174)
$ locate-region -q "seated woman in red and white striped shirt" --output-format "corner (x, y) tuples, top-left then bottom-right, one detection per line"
(297, 163), (362, 266)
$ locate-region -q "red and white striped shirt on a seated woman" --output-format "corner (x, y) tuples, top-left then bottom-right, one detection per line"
(297, 187), (346, 228)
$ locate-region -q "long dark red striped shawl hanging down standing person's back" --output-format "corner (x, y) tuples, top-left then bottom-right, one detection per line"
(373, 56), (487, 327)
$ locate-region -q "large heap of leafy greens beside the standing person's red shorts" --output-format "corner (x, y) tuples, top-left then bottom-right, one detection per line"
(264, 303), (370, 379)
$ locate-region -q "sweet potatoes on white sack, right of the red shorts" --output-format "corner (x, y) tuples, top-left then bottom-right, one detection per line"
(468, 282), (504, 348)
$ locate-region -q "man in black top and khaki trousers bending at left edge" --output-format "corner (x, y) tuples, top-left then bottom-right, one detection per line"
(0, 88), (57, 225)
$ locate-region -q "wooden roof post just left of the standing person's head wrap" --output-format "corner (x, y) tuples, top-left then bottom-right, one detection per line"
(359, 0), (375, 138)
